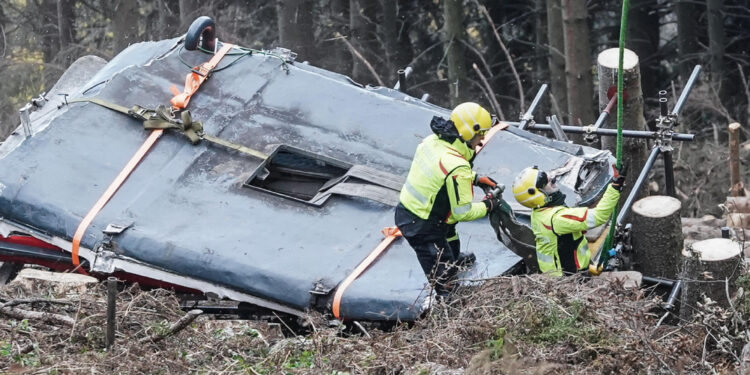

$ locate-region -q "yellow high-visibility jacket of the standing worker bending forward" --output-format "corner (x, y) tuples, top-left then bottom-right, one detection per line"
(399, 134), (487, 224)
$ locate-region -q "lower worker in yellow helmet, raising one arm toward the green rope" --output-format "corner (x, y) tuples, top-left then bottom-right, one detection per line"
(513, 167), (625, 276)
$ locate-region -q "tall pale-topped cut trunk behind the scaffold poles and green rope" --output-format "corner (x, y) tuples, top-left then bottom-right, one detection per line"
(597, 48), (648, 202)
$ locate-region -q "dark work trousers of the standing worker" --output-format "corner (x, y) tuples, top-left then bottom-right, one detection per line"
(395, 204), (460, 295)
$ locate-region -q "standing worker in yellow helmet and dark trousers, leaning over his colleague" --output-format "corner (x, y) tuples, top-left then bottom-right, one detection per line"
(395, 102), (498, 296)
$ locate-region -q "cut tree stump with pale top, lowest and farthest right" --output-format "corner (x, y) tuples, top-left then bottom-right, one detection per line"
(680, 238), (742, 320)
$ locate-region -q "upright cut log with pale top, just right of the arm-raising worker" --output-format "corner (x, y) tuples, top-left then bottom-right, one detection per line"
(631, 195), (683, 279)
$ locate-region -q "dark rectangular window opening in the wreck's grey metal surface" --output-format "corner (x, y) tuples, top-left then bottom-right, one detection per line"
(244, 145), (351, 206)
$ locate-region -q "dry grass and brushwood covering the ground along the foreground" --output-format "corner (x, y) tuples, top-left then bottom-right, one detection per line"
(0, 276), (746, 374)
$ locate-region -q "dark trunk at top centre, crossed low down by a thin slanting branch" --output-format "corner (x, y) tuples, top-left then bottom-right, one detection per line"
(349, 0), (380, 83)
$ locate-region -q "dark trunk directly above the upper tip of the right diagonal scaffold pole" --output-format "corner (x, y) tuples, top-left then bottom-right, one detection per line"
(674, 0), (700, 82)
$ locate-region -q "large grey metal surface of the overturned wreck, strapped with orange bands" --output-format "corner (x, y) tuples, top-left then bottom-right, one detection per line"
(0, 41), (612, 320)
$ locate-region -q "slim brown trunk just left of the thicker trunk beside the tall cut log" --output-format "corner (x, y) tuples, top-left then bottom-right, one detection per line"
(547, 0), (572, 123)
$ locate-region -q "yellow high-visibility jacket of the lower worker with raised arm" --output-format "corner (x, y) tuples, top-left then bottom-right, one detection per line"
(531, 185), (620, 276)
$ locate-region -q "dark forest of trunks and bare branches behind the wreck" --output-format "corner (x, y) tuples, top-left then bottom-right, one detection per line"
(0, 0), (750, 216)
